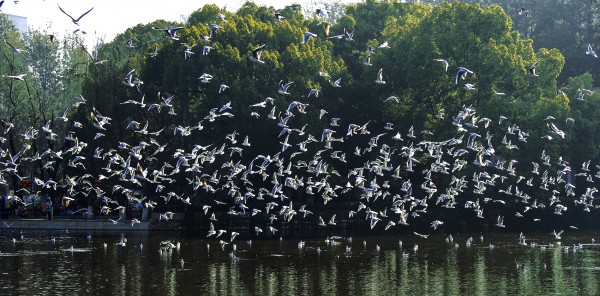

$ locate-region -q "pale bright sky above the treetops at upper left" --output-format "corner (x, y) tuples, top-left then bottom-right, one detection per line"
(1, 0), (348, 44)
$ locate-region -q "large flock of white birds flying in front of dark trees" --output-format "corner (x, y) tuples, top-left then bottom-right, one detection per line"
(0, 3), (600, 250)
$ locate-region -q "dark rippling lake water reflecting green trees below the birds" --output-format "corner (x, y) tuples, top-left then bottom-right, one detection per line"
(0, 230), (600, 295)
